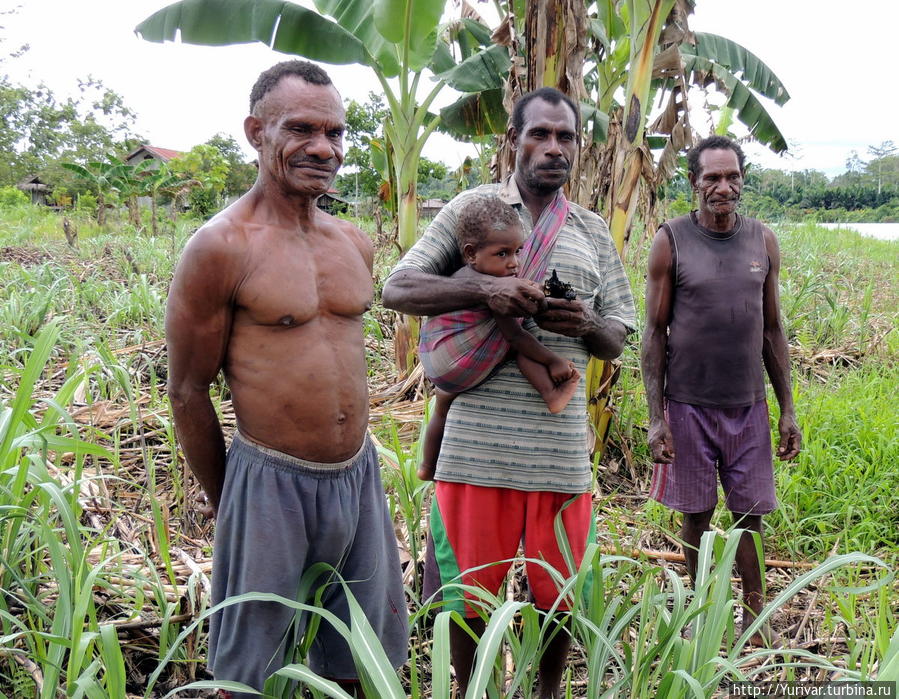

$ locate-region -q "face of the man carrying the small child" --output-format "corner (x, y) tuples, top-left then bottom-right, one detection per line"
(510, 97), (577, 194)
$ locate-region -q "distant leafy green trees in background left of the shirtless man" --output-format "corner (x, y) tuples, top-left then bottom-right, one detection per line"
(0, 15), (256, 222)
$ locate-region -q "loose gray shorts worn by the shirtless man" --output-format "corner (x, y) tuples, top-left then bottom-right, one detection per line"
(209, 434), (409, 696)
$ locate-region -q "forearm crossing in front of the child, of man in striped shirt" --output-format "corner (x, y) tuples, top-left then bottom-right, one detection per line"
(381, 267), (544, 316)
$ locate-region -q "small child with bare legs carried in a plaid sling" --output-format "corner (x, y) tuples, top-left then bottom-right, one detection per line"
(418, 196), (580, 481)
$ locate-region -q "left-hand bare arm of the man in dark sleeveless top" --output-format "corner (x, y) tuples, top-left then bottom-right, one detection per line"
(640, 229), (674, 464)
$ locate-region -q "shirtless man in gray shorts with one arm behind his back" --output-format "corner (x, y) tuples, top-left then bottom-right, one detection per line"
(166, 61), (408, 696)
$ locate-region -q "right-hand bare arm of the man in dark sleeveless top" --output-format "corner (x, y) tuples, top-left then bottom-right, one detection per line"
(762, 228), (802, 461)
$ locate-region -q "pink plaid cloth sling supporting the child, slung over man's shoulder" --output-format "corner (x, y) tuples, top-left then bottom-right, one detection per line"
(418, 190), (568, 393)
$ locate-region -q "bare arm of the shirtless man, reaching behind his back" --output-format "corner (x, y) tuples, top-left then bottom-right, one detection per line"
(165, 229), (241, 512)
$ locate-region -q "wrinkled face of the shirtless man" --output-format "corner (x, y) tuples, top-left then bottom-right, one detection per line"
(248, 76), (345, 194)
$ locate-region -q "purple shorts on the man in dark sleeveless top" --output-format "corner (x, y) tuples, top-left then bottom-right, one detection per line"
(649, 400), (777, 515)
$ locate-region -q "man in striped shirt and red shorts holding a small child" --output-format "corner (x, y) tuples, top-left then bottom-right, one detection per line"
(383, 88), (636, 697)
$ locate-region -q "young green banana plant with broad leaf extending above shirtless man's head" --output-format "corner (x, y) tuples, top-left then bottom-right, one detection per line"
(135, 0), (444, 251)
